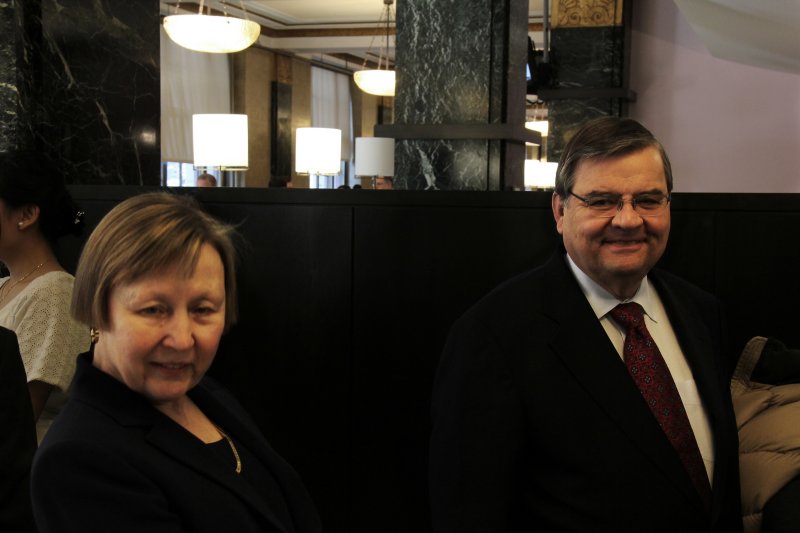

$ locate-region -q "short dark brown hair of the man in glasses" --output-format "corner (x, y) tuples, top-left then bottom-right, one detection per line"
(556, 117), (672, 199)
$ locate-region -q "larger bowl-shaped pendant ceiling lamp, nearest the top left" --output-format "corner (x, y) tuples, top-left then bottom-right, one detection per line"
(164, 0), (261, 54)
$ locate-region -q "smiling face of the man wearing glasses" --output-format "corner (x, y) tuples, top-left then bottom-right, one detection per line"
(552, 147), (670, 299)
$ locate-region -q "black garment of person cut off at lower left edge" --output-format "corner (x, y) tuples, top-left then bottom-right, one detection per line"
(0, 328), (36, 531)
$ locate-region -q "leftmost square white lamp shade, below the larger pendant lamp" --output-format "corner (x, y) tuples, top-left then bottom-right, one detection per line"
(192, 114), (248, 170)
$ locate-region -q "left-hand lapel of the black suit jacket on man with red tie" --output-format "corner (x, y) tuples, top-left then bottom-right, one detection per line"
(545, 254), (703, 508)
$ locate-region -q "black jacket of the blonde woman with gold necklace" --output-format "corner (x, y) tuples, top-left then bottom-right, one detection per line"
(32, 354), (321, 533)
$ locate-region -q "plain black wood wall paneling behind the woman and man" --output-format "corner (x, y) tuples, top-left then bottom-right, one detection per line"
(61, 186), (800, 533)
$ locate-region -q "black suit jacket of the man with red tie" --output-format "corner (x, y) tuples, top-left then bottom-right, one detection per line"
(430, 253), (741, 533)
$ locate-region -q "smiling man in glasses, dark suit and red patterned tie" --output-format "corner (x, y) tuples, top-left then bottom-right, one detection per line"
(430, 117), (741, 533)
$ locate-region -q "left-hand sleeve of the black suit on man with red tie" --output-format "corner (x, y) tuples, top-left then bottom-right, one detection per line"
(429, 316), (526, 533)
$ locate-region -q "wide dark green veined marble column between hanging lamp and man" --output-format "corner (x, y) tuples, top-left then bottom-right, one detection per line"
(382, 0), (533, 190)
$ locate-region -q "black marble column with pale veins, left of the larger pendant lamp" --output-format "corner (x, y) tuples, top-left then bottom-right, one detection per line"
(36, 0), (161, 185)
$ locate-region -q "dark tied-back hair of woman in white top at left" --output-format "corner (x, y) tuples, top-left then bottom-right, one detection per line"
(0, 150), (83, 245)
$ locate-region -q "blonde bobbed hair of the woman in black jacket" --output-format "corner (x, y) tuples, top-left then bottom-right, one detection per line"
(71, 192), (237, 330)
